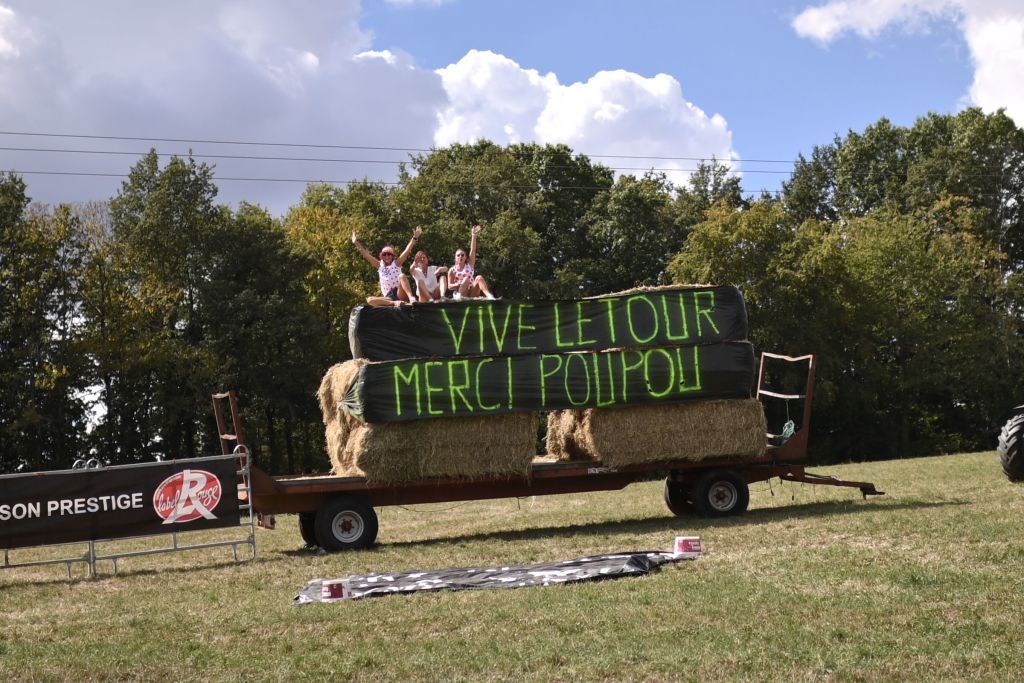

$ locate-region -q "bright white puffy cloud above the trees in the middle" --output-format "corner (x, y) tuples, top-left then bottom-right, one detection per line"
(434, 50), (736, 187)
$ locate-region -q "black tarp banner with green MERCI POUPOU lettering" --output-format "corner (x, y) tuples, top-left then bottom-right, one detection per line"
(344, 342), (755, 423)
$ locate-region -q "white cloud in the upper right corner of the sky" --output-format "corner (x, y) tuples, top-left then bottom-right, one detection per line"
(793, 0), (1024, 125)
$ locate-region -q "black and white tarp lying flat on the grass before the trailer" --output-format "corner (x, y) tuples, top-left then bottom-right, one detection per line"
(295, 551), (692, 605)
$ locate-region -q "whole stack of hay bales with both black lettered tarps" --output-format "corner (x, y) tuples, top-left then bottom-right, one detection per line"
(331, 286), (766, 482)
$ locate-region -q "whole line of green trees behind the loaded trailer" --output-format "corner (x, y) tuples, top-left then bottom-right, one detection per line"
(0, 109), (1024, 472)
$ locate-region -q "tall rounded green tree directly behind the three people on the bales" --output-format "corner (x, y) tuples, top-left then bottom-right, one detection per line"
(393, 140), (612, 298)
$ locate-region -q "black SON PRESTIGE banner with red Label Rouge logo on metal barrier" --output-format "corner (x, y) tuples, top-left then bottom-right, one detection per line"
(0, 456), (240, 549)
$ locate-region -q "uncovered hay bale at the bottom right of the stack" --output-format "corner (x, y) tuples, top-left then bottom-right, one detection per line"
(573, 398), (767, 467)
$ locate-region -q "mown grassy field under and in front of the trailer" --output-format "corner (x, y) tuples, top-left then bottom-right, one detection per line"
(0, 453), (1024, 681)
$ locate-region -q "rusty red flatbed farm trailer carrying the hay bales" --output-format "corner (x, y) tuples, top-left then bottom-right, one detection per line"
(222, 353), (883, 552)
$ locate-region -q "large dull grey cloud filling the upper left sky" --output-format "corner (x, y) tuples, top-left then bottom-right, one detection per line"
(0, 0), (445, 213)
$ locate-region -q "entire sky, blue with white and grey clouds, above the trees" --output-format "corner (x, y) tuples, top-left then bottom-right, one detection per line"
(0, 0), (1024, 214)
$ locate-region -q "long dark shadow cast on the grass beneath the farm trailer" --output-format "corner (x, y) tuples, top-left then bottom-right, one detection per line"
(378, 501), (968, 554)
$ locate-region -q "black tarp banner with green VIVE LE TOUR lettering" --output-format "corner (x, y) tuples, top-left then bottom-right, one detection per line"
(348, 287), (746, 360)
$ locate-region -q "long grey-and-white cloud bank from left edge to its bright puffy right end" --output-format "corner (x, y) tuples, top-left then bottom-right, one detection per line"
(0, 0), (735, 213)
